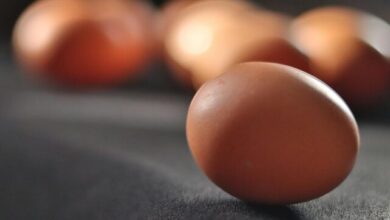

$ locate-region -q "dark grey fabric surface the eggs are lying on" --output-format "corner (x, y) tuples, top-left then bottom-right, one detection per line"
(0, 47), (390, 219)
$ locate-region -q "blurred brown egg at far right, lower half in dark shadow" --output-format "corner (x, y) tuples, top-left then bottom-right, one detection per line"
(291, 7), (390, 106)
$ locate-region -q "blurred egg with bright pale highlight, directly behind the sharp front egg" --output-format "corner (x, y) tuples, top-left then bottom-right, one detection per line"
(165, 1), (307, 88)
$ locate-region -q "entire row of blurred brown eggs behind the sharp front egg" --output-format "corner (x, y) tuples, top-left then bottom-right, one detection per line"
(13, 0), (390, 107)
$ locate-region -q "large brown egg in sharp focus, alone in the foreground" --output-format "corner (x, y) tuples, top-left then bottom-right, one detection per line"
(187, 62), (359, 204)
